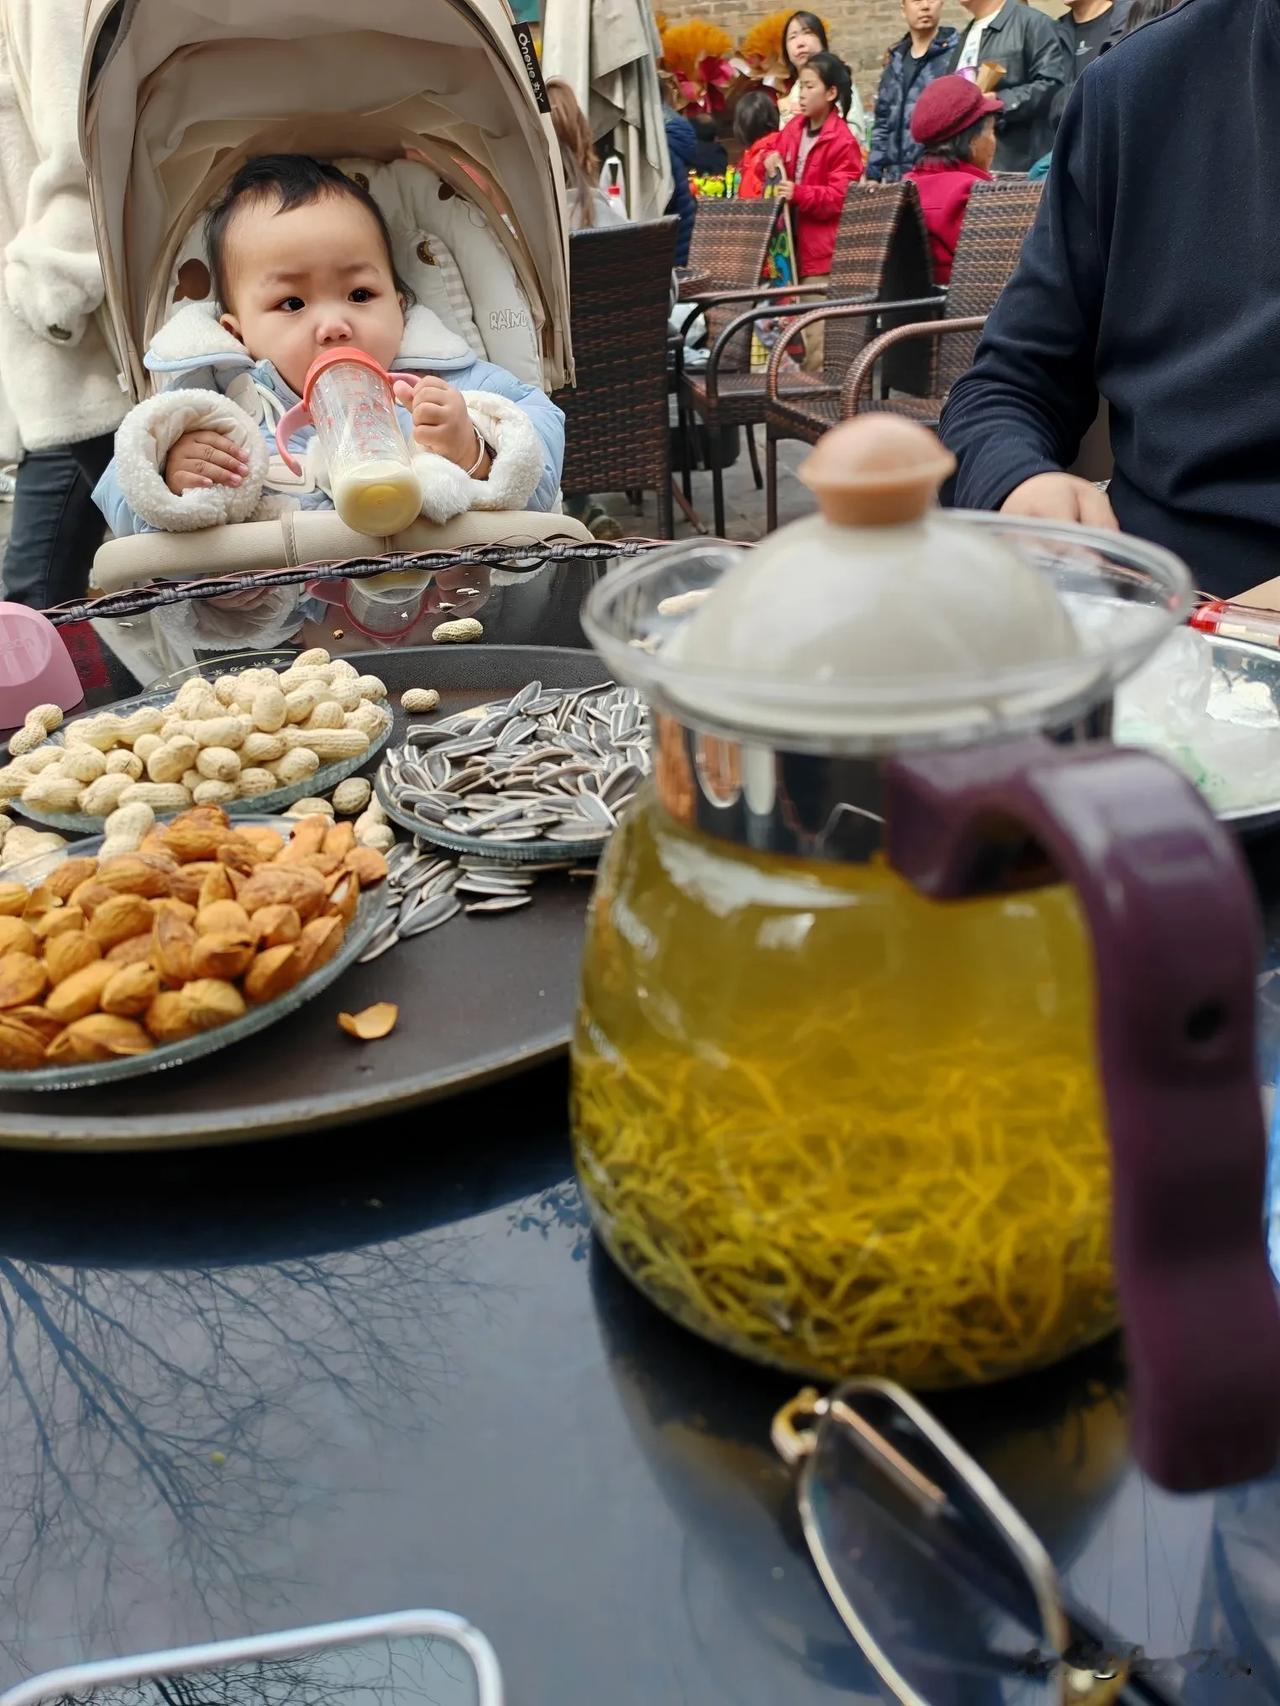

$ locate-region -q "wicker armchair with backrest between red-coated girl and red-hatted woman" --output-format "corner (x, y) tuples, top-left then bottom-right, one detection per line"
(681, 184), (928, 534)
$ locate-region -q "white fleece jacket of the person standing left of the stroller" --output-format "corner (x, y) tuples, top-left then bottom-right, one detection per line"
(0, 0), (128, 457)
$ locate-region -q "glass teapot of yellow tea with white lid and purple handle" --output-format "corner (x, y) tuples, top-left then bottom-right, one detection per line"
(573, 416), (1280, 1488)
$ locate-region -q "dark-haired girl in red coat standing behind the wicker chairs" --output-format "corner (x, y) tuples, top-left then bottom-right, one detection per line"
(770, 53), (866, 374)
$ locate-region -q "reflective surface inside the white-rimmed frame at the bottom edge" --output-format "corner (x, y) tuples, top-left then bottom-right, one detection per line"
(49, 1636), (478, 1706)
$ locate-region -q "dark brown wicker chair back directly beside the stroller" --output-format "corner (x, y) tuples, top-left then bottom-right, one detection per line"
(555, 218), (678, 539)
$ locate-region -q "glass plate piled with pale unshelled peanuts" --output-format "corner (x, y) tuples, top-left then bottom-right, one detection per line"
(0, 647), (391, 836)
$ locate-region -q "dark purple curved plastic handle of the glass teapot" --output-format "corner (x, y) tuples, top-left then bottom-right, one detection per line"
(886, 739), (1280, 1491)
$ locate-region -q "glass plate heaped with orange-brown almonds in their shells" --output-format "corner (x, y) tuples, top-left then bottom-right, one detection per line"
(0, 802), (387, 1090)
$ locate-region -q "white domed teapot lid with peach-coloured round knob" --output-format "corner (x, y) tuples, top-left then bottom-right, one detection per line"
(669, 415), (1082, 737)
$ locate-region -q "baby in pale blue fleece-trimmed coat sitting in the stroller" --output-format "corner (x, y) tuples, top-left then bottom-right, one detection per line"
(94, 154), (563, 534)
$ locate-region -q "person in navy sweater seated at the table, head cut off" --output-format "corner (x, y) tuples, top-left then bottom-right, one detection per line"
(942, 0), (1280, 597)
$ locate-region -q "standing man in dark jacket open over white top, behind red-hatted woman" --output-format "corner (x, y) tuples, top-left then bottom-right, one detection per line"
(947, 0), (1072, 172)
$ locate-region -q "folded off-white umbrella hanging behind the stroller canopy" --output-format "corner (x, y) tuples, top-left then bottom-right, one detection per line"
(543, 0), (672, 220)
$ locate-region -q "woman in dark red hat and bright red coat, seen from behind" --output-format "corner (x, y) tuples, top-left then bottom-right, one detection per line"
(906, 77), (1004, 285)
